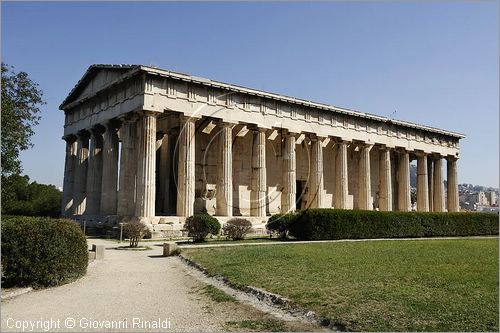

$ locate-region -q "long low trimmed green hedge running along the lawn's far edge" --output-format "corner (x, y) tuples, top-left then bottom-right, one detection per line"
(270, 209), (499, 240)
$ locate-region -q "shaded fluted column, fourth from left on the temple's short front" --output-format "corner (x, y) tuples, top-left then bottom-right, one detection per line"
(101, 122), (119, 215)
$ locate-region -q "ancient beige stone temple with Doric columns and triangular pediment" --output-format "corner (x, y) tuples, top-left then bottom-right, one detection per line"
(60, 65), (464, 231)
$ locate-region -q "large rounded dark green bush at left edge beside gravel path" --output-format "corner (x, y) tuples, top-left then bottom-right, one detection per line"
(2, 216), (88, 287)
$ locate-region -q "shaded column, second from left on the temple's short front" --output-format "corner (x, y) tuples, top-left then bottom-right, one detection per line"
(74, 131), (89, 215)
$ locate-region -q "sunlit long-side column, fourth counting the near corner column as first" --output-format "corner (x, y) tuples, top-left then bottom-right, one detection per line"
(250, 128), (267, 217)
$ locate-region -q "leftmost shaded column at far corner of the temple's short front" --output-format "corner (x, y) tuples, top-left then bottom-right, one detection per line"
(61, 135), (77, 216)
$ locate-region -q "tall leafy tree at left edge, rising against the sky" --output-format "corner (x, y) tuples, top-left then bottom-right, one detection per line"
(1, 63), (45, 204)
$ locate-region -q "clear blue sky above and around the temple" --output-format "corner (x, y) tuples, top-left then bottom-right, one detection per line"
(1, 1), (499, 187)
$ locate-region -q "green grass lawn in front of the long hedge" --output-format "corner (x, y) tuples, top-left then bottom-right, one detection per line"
(183, 239), (499, 331)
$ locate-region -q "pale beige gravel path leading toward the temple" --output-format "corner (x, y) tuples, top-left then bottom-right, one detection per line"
(1, 239), (292, 331)
